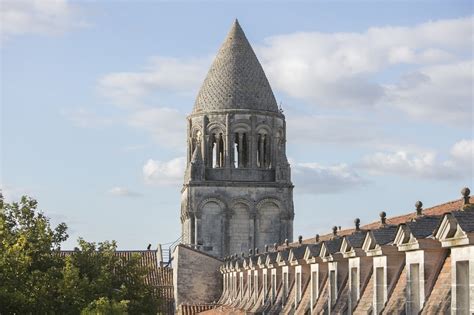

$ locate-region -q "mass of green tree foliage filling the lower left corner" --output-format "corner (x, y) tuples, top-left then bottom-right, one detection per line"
(0, 195), (159, 314)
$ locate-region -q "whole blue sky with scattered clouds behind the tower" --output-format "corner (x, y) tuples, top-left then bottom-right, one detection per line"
(0, 0), (474, 249)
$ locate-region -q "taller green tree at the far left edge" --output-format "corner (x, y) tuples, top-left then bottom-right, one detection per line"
(0, 196), (68, 314)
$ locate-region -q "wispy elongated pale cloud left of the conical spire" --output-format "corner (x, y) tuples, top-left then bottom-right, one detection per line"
(99, 56), (210, 107)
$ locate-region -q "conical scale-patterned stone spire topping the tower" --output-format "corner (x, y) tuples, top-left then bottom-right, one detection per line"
(194, 19), (278, 113)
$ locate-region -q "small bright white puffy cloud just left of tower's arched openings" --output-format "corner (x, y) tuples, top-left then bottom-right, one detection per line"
(143, 157), (186, 185)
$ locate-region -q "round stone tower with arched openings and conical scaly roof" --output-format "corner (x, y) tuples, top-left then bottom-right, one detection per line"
(181, 20), (294, 257)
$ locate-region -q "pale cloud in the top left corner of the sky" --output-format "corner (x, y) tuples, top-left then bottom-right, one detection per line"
(0, 0), (87, 39)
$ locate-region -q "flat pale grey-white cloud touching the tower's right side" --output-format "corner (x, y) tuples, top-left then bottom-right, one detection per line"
(292, 163), (368, 194)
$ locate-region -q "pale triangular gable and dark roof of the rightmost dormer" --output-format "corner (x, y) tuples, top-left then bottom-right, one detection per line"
(435, 210), (474, 247)
